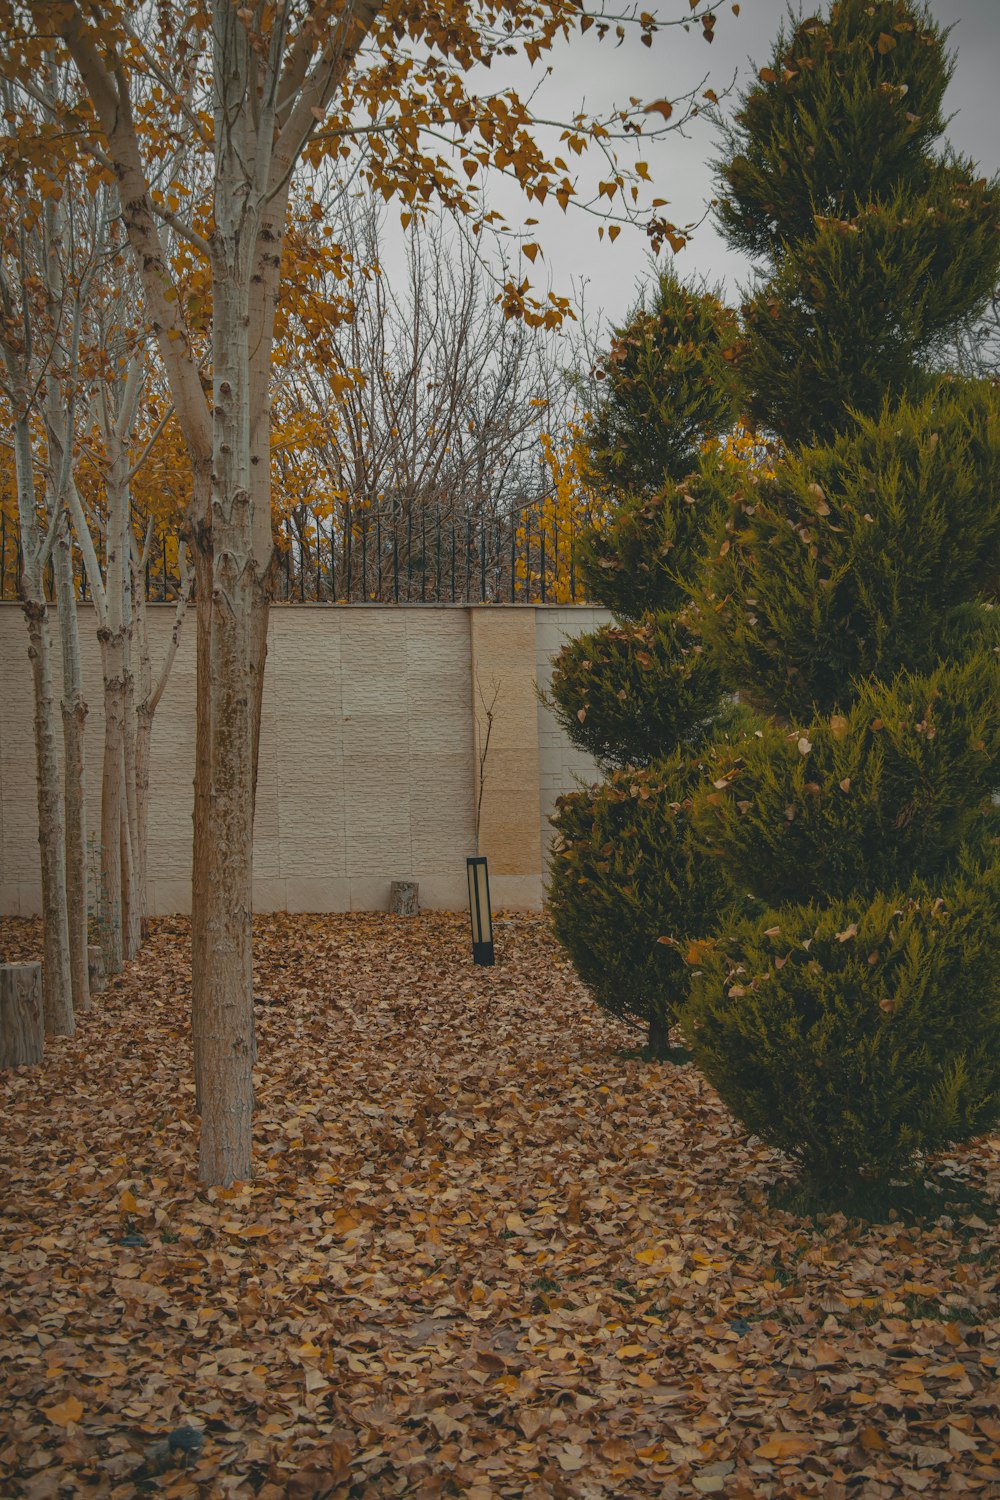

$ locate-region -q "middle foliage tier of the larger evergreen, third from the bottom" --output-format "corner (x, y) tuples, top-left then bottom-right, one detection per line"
(699, 383), (1000, 722)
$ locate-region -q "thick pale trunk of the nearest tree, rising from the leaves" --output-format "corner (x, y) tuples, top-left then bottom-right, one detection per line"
(192, 246), (257, 1184)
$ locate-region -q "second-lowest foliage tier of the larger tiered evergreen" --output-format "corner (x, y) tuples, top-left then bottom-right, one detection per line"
(696, 653), (1000, 906)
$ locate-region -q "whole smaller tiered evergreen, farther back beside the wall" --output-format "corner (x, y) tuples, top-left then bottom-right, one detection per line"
(549, 275), (746, 1058)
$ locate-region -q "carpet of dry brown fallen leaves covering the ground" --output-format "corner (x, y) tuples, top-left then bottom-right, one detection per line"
(0, 914), (1000, 1500)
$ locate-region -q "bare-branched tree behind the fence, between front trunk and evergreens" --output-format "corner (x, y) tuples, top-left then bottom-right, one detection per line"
(279, 195), (564, 516)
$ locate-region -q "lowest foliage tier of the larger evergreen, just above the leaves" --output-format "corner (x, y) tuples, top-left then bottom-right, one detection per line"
(682, 861), (1000, 1197)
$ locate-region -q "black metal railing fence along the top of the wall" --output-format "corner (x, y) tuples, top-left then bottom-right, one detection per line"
(0, 497), (601, 605)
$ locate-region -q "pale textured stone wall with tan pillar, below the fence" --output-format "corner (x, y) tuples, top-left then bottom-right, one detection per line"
(0, 605), (607, 915)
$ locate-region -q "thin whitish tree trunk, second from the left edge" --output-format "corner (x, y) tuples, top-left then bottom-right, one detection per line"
(49, 516), (90, 1014)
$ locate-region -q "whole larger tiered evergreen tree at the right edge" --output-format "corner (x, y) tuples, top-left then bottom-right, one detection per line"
(685, 0), (1000, 1197)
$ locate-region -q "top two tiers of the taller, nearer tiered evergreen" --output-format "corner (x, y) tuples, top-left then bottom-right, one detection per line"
(717, 0), (1000, 443)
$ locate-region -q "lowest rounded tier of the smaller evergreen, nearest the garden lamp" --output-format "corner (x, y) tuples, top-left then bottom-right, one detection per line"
(549, 753), (743, 1058)
